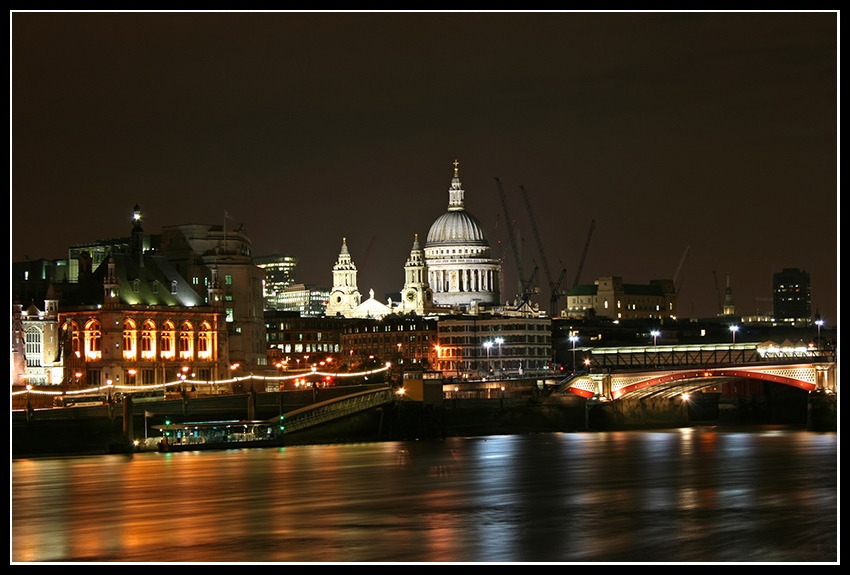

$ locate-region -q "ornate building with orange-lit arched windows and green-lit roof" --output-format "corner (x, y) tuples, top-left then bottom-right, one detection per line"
(51, 214), (229, 388)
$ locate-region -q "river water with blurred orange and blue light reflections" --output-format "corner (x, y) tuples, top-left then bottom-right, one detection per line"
(10, 427), (840, 564)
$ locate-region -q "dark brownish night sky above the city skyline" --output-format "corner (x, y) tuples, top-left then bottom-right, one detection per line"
(10, 12), (838, 325)
